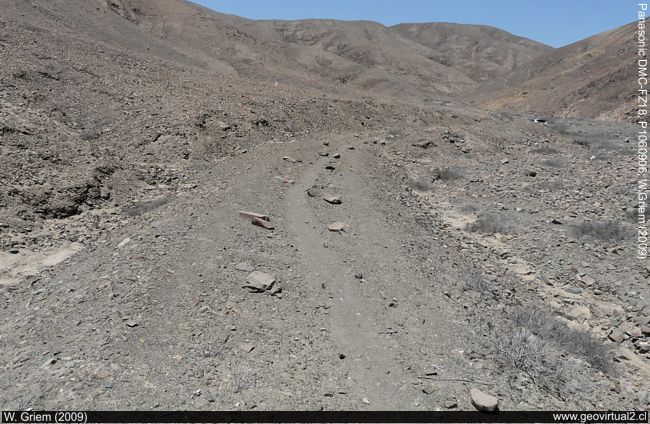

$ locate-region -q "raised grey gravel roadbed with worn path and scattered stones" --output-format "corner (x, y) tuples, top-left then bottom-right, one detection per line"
(1, 134), (474, 409)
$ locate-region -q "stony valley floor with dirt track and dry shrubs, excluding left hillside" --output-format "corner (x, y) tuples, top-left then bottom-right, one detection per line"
(1, 108), (650, 409)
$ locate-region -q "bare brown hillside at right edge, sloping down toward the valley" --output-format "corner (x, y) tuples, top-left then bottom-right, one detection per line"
(483, 23), (636, 120)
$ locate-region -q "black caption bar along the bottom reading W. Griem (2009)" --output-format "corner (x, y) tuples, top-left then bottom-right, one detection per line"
(0, 411), (648, 424)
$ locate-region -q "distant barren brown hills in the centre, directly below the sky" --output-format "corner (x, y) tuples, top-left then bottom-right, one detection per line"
(111, 0), (550, 98)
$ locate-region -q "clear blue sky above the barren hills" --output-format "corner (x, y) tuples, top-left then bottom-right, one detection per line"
(192, 0), (638, 47)
